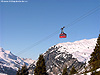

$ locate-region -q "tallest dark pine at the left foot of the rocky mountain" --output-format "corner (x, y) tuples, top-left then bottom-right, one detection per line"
(34, 55), (48, 75)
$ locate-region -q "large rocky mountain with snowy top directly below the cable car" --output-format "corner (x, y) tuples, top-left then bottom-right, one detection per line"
(44, 38), (97, 75)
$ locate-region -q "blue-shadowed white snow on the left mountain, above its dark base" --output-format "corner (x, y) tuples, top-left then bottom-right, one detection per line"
(0, 47), (34, 70)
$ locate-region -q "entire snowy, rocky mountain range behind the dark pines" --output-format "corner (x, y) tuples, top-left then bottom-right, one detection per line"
(0, 38), (97, 75)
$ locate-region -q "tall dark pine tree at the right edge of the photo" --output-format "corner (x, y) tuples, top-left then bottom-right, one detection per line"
(89, 34), (100, 69)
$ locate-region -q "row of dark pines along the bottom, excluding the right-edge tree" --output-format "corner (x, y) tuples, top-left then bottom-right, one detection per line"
(16, 55), (77, 75)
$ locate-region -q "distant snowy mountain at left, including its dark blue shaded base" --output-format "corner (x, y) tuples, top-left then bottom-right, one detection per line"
(0, 48), (34, 75)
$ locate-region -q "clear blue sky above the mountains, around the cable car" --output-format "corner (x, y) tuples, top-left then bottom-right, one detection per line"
(0, 0), (100, 60)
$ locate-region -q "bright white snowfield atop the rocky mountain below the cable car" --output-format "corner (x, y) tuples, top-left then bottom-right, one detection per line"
(56, 38), (97, 63)
